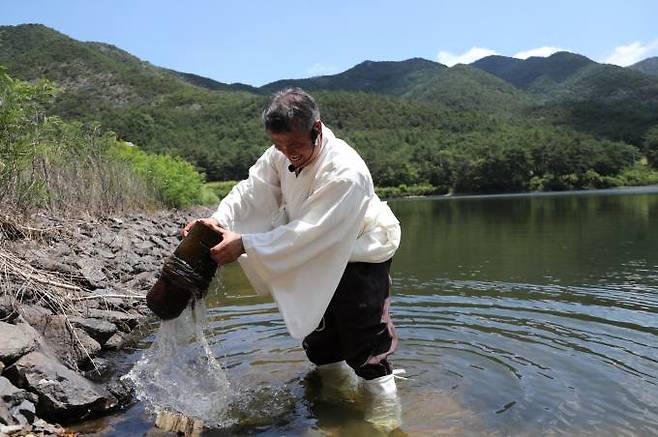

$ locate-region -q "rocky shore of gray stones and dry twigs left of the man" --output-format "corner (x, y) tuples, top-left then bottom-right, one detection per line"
(0, 209), (210, 436)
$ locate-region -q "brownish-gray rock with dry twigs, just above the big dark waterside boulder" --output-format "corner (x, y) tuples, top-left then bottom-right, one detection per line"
(24, 315), (101, 369)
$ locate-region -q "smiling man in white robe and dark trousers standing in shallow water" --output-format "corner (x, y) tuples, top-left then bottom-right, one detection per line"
(183, 88), (400, 394)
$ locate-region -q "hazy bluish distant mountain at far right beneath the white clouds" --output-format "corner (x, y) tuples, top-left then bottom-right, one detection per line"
(471, 52), (658, 145)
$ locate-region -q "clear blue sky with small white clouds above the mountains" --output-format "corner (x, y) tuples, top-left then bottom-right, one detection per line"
(0, 0), (658, 85)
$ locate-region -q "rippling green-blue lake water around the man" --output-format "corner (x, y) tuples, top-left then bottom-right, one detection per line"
(74, 187), (658, 436)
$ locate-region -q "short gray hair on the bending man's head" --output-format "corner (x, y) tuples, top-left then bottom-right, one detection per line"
(262, 88), (320, 133)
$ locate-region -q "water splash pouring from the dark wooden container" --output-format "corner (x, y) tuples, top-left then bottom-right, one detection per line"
(123, 300), (232, 426)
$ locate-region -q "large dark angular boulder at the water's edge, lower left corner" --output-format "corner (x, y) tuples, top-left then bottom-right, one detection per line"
(5, 352), (117, 421)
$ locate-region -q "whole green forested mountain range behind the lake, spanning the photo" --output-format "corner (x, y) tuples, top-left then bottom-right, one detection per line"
(0, 25), (658, 192)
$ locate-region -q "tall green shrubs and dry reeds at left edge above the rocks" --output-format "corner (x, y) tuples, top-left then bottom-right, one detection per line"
(0, 68), (157, 215)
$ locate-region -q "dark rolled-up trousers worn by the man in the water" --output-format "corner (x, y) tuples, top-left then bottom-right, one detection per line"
(302, 260), (398, 379)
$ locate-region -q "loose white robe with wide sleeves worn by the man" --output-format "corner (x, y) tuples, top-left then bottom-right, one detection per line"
(212, 125), (400, 339)
